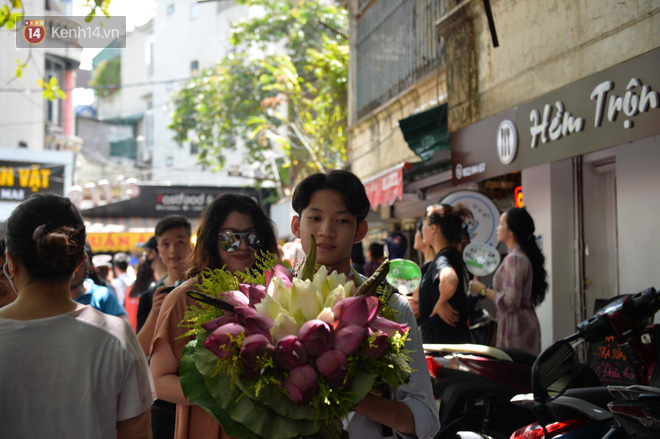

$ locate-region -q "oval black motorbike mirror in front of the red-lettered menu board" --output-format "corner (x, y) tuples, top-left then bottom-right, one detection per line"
(532, 340), (579, 404)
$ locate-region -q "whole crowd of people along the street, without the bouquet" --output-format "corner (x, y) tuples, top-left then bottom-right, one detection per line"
(0, 170), (547, 439)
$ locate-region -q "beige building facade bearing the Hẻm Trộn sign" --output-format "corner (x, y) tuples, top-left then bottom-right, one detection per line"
(350, 0), (660, 346)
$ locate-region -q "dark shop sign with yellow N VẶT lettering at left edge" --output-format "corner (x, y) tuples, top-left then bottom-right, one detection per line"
(0, 160), (64, 202)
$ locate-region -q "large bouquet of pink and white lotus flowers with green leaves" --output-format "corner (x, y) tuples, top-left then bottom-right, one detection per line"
(179, 241), (412, 439)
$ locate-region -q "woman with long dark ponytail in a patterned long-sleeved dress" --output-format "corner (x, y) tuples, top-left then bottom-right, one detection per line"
(470, 207), (548, 354)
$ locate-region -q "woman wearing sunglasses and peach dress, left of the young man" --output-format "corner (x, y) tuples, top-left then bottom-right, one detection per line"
(151, 194), (277, 439)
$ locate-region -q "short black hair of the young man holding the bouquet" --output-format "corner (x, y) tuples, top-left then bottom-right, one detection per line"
(291, 169), (371, 223)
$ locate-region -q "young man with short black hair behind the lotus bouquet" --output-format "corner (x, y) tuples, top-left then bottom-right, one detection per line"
(291, 170), (440, 438)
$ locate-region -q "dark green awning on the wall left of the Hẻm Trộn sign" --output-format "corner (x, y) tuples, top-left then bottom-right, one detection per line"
(399, 104), (451, 162)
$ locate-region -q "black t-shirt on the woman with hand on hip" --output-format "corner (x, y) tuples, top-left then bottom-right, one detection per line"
(419, 247), (472, 343)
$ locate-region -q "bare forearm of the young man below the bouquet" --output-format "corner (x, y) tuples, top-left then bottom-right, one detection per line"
(355, 393), (415, 436)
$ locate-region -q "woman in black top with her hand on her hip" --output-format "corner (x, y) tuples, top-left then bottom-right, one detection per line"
(419, 203), (472, 343)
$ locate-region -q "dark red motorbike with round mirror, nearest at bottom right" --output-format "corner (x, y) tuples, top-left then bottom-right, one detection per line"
(511, 288), (660, 439)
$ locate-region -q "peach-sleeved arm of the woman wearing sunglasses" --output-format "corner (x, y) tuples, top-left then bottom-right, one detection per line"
(151, 284), (190, 405)
